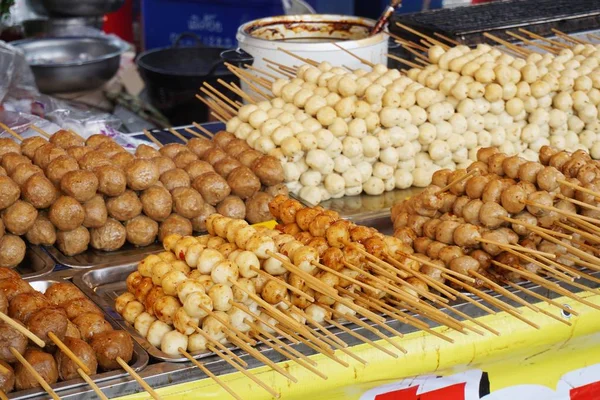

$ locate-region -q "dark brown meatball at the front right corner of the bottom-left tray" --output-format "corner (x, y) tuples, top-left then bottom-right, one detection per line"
(90, 331), (133, 370)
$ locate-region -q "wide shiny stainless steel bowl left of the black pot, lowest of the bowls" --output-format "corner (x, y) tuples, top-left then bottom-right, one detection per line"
(11, 37), (125, 93)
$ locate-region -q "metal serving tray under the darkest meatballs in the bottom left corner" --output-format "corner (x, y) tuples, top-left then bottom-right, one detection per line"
(8, 275), (149, 400)
